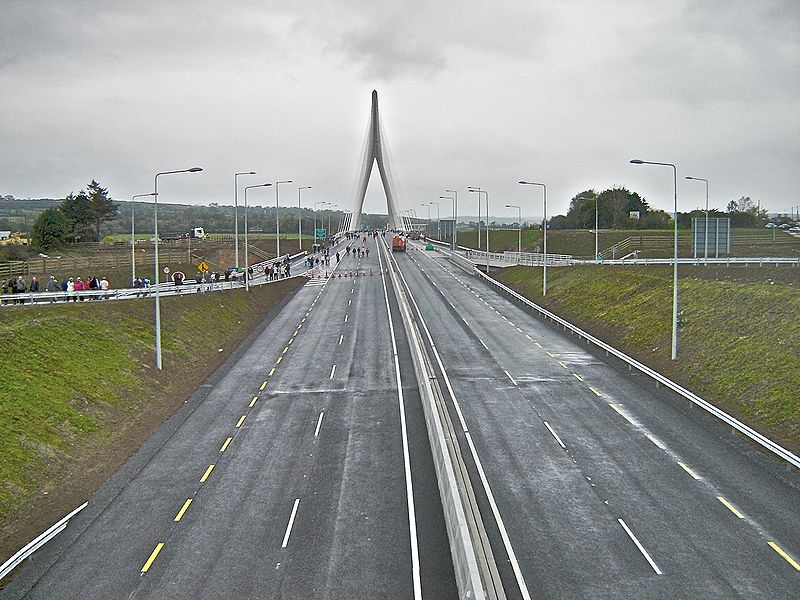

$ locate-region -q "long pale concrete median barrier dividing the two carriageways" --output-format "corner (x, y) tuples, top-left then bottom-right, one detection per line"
(388, 241), (505, 600)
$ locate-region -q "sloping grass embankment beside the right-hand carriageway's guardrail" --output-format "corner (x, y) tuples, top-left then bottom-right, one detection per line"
(498, 266), (800, 452)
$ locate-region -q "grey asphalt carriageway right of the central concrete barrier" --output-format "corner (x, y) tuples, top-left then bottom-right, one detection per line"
(386, 244), (800, 599)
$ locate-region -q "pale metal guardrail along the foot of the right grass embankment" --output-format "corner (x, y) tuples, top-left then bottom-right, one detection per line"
(450, 255), (800, 469)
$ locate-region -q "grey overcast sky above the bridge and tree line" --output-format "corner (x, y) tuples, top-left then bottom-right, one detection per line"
(0, 0), (800, 217)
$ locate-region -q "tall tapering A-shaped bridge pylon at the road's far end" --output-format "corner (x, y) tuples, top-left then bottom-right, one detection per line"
(346, 90), (408, 231)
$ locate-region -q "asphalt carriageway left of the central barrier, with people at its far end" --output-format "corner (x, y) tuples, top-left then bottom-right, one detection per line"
(0, 234), (457, 600)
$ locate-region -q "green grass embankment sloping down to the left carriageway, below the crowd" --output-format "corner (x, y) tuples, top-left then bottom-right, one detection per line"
(0, 279), (303, 561)
